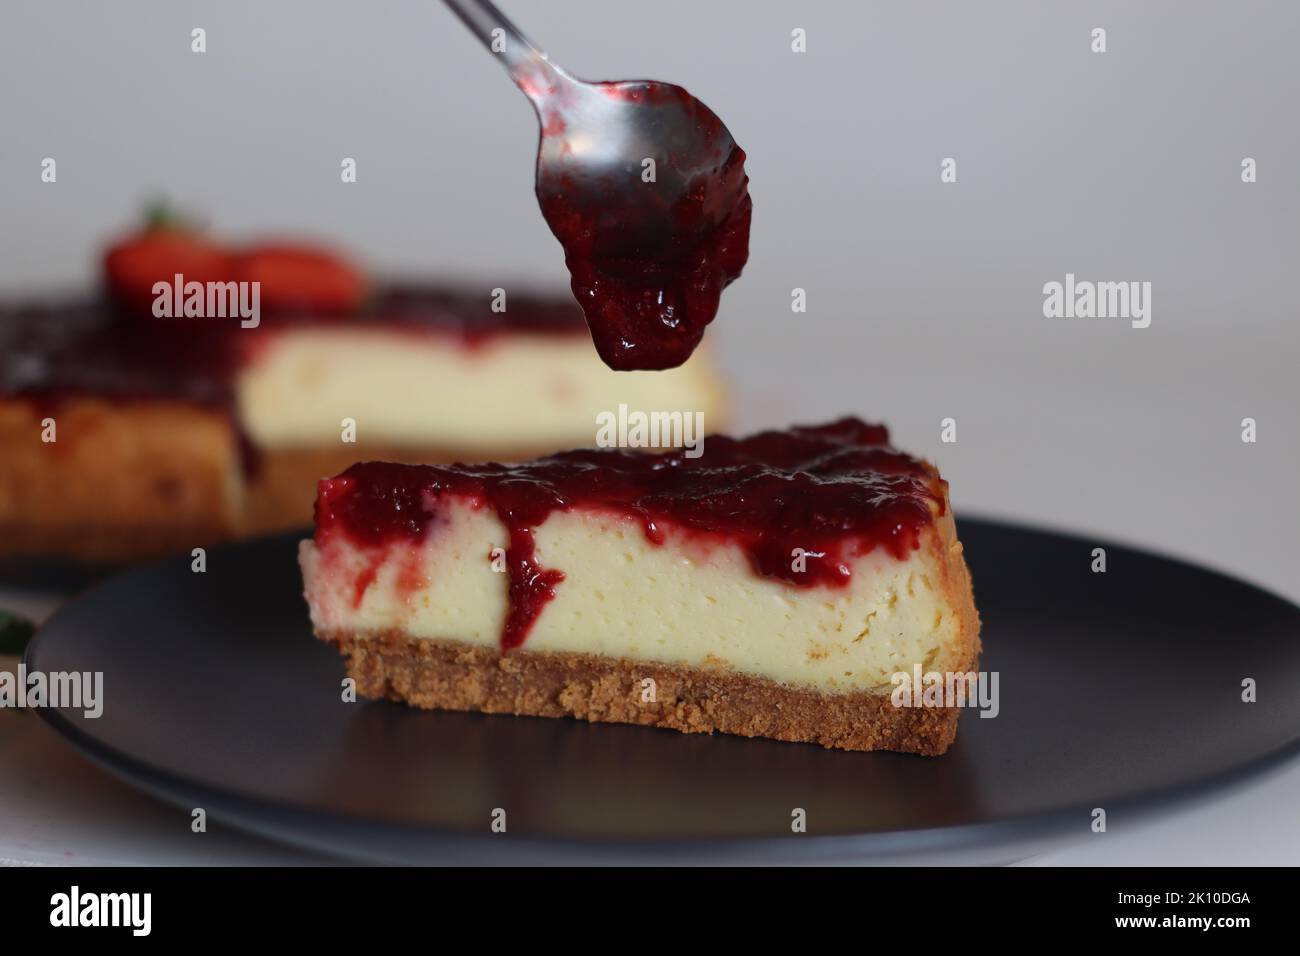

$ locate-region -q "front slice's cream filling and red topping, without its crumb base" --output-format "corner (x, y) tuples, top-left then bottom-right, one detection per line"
(303, 419), (970, 691)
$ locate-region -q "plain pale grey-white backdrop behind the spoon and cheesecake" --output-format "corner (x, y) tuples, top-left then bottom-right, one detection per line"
(0, 0), (1300, 862)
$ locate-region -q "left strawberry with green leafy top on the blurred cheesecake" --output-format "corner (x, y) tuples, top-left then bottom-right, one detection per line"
(104, 215), (233, 312)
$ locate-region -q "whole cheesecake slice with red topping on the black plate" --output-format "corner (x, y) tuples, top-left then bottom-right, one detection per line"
(300, 419), (979, 754)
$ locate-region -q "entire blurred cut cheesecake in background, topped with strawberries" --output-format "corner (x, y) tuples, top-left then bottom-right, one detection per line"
(0, 217), (725, 562)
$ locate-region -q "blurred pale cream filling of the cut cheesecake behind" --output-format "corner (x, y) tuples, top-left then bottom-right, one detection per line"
(235, 326), (724, 455)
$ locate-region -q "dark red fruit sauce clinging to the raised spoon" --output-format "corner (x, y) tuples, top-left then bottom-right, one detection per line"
(538, 82), (753, 371)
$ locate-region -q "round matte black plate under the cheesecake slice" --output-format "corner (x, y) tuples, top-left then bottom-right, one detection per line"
(29, 520), (1300, 861)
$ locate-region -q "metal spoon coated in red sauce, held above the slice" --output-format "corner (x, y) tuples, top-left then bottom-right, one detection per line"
(446, 0), (751, 371)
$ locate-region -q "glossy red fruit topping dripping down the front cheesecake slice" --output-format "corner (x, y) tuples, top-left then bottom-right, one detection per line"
(316, 418), (945, 652)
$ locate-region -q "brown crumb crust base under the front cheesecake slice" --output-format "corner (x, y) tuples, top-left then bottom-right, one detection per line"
(317, 631), (959, 756)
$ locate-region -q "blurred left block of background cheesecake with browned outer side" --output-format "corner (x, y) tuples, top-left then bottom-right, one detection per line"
(0, 302), (247, 564)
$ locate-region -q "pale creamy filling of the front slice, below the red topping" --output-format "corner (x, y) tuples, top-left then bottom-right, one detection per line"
(302, 497), (965, 693)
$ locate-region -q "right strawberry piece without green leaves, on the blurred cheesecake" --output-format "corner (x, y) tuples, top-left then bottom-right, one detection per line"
(235, 243), (365, 312)
